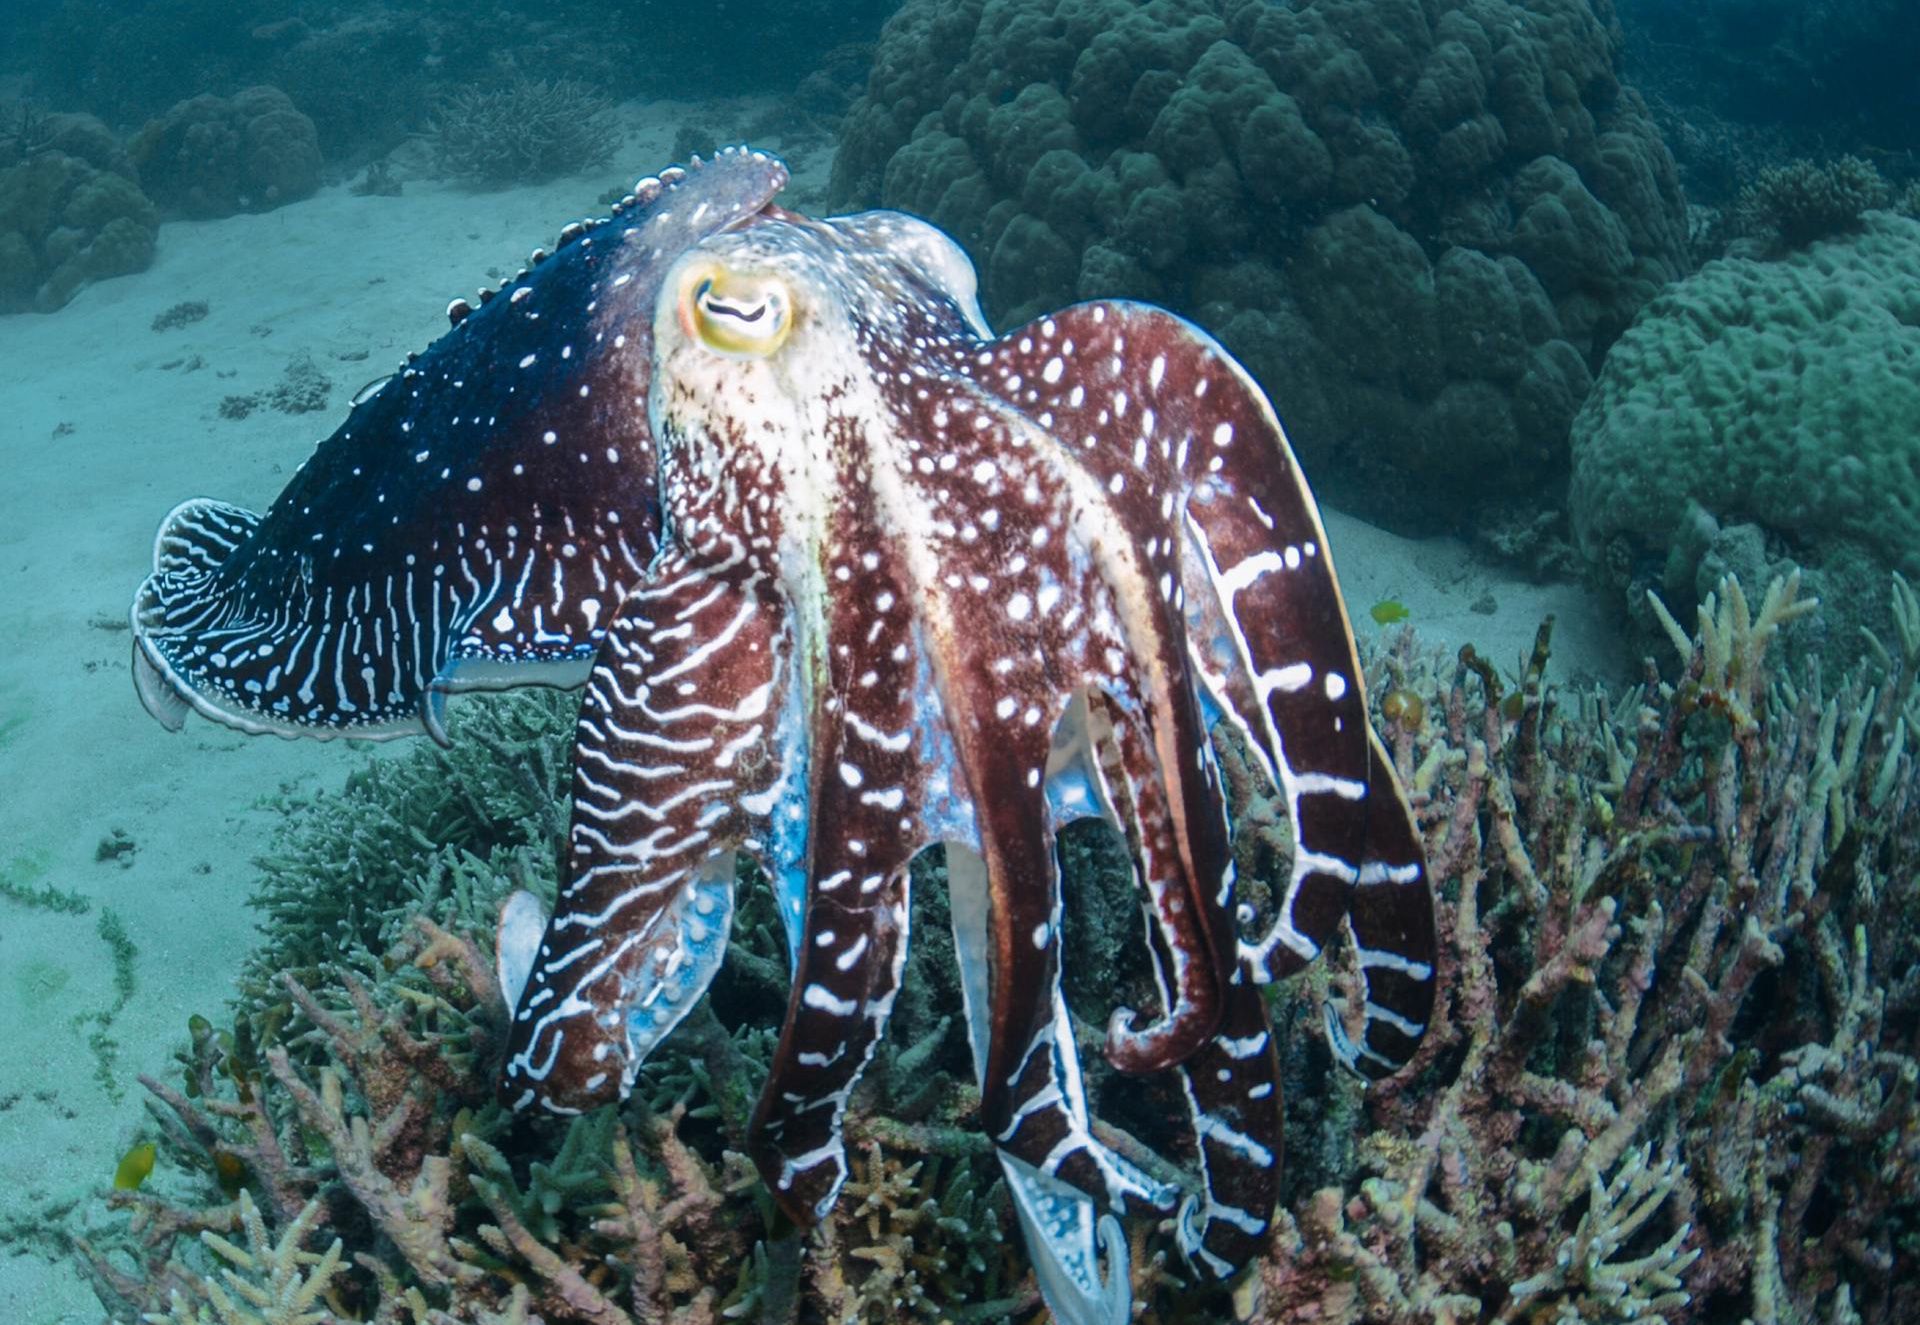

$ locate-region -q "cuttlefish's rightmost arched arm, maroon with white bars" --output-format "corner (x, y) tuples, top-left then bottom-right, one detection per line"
(983, 303), (1434, 1075)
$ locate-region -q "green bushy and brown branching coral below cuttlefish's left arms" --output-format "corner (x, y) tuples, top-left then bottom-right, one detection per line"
(77, 691), (1039, 1325)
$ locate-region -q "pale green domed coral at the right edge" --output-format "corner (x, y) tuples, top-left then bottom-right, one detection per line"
(1571, 211), (1920, 595)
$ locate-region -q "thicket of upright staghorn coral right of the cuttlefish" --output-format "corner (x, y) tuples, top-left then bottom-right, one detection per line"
(1228, 580), (1920, 1323)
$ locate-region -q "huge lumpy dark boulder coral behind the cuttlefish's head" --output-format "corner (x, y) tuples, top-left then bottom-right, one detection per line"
(833, 0), (1686, 526)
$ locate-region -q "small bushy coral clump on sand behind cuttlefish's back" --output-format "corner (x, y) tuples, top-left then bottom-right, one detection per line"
(430, 79), (618, 188)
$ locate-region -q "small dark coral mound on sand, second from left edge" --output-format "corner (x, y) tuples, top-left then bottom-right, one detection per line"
(129, 86), (321, 219)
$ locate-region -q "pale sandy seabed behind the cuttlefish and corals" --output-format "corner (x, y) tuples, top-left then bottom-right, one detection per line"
(0, 104), (1619, 1325)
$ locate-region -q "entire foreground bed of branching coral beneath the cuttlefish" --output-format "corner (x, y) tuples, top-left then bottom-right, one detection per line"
(79, 578), (1920, 1325)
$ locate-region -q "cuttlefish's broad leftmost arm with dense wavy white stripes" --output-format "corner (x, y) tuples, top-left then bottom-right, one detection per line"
(499, 537), (795, 1114)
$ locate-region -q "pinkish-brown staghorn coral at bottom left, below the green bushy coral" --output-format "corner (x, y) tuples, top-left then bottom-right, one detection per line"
(81, 922), (1037, 1325)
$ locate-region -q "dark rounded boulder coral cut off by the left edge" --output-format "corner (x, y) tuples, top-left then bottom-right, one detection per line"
(0, 115), (159, 313)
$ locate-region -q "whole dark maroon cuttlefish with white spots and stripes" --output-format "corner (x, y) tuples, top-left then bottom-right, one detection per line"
(134, 152), (1434, 1323)
